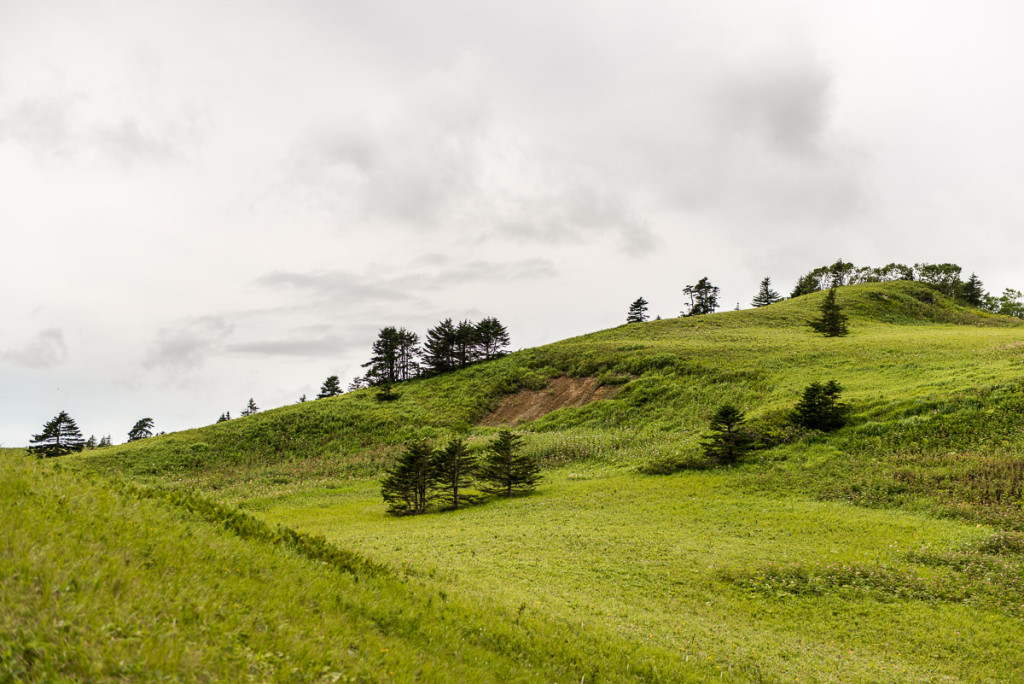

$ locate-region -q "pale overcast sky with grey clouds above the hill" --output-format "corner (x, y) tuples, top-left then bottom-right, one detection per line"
(0, 0), (1024, 446)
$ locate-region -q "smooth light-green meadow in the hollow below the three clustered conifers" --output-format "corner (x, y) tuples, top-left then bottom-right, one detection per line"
(247, 467), (1024, 682)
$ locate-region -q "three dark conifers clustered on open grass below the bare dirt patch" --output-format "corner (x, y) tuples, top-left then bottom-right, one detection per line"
(381, 430), (541, 515)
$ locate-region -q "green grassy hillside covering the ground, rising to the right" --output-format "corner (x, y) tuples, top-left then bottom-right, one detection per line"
(6, 283), (1024, 682)
